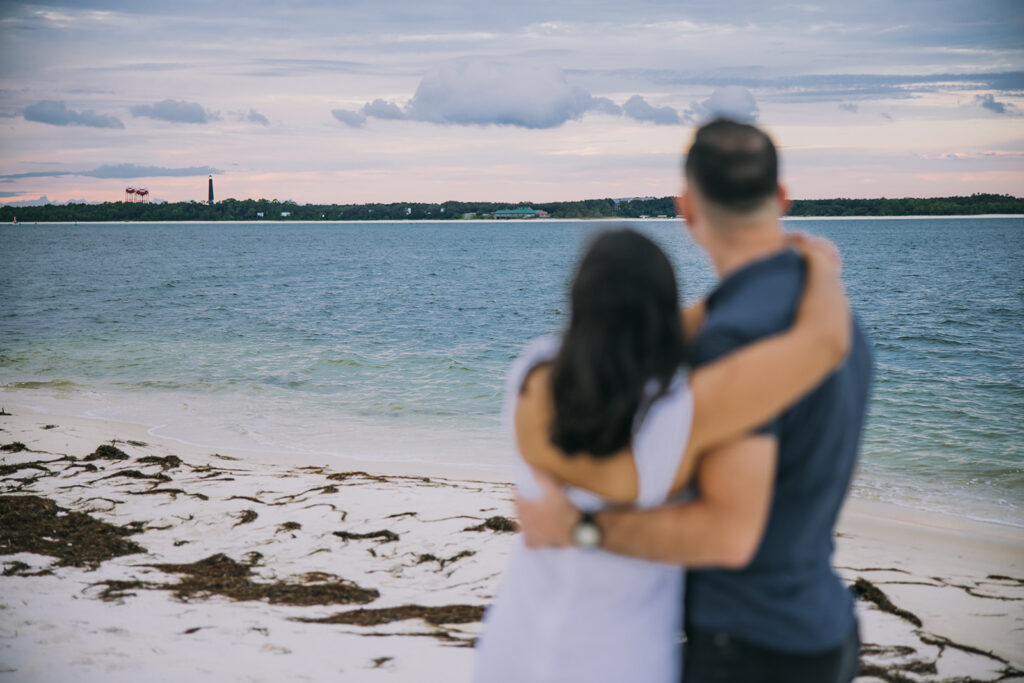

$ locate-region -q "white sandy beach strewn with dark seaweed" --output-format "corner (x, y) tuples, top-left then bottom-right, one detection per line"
(0, 404), (1024, 683)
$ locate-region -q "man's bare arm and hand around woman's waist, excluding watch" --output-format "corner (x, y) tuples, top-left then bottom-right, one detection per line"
(516, 435), (777, 568)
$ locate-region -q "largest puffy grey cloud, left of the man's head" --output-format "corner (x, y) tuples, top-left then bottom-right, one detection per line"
(407, 58), (594, 129)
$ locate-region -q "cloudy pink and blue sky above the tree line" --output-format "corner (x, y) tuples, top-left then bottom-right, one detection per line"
(0, 0), (1024, 204)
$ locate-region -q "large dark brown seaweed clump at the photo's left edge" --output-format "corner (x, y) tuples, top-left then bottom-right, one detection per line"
(0, 496), (145, 566)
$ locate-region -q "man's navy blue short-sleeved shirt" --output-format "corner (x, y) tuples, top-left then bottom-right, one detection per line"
(686, 250), (871, 652)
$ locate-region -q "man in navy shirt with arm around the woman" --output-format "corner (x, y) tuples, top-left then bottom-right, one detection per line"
(518, 119), (871, 683)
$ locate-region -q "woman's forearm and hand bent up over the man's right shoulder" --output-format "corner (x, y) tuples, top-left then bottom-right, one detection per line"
(787, 232), (852, 365)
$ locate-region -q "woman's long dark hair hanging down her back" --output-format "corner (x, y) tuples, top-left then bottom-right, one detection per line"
(551, 228), (685, 458)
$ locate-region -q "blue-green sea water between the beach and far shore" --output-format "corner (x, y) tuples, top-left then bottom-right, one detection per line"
(0, 222), (1024, 526)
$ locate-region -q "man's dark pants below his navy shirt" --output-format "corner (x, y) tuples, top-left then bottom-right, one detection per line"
(683, 623), (860, 683)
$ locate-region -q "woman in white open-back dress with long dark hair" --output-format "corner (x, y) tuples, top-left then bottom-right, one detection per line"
(475, 229), (850, 683)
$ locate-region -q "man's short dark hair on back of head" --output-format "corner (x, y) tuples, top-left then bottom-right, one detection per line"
(685, 119), (778, 213)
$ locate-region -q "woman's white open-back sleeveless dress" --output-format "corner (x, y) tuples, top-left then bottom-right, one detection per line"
(473, 337), (693, 683)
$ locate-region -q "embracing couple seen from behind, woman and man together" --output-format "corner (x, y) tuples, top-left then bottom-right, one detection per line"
(474, 119), (871, 683)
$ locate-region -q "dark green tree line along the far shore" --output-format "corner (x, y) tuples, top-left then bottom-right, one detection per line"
(0, 195), (1024, 222)
